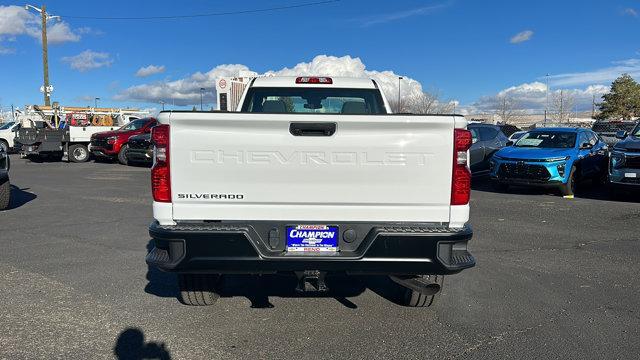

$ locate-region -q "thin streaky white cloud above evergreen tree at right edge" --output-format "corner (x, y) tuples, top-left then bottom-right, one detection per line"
(549, 59), (640, 87)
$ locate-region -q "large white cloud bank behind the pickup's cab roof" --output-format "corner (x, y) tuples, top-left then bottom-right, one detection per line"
(115, 55), (422, 106)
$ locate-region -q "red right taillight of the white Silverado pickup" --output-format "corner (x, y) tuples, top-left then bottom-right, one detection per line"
(451, 129), (473, 205)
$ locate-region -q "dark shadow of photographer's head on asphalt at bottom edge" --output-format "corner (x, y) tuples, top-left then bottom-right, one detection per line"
(113, 328), (171, 360)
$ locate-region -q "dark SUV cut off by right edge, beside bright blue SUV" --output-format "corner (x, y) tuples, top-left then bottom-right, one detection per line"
(609, 124), (640, 188)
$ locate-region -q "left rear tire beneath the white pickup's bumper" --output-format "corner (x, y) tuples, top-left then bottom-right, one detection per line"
(178, 274), (220, 306)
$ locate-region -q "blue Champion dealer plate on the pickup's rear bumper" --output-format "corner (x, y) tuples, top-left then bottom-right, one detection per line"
(287, 225), (338, 252)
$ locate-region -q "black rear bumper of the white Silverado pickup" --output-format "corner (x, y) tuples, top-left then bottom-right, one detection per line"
(146, 221), (475, 275)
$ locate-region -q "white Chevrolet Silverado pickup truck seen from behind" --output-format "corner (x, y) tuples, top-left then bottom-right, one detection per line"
(146, 77), (475, 306)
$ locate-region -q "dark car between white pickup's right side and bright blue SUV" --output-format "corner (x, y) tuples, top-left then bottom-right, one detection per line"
(467, 124), (510, 176)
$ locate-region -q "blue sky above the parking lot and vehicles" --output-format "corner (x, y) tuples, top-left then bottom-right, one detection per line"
(0, 0), (640, 110)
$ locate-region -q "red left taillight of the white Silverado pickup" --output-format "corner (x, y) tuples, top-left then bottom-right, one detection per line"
(151, 124), (171, 202)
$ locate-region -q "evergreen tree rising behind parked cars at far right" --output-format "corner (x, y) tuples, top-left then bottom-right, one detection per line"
(596, 74), (640, 120)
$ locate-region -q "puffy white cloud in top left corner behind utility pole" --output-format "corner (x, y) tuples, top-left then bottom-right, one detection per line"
(0, 5), (84, 44)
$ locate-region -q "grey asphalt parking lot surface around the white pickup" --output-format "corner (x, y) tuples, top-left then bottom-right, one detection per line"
(0, 155), (640, 359)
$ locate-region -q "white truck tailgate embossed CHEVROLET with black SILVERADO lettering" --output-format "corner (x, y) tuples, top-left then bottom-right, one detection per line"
(166, 112), (454, 222)
